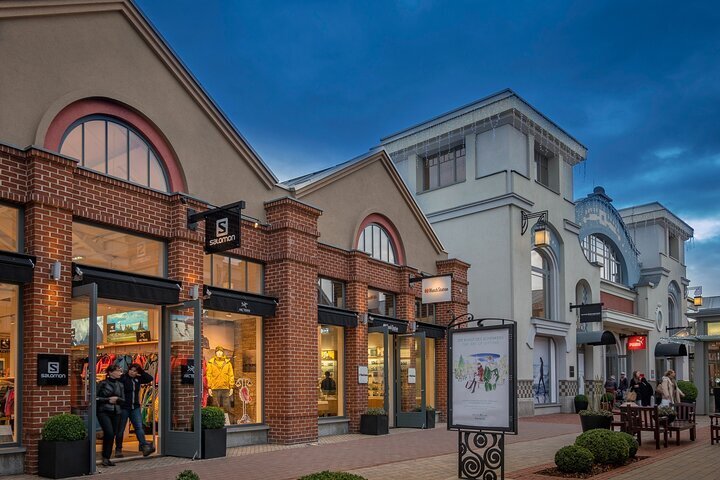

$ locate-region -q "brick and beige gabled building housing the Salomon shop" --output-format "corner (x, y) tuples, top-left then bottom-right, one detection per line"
(0, 1), (468, 473)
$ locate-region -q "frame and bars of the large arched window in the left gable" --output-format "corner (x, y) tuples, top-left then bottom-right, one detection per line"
(58, 114), (171, 193)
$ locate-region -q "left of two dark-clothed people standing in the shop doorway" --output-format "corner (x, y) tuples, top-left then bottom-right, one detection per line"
(95, 364), (125, 467)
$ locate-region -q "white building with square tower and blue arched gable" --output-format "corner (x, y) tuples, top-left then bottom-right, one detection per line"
(380, 90), (692, 416)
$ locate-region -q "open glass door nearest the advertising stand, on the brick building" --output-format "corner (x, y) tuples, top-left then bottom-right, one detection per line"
(395, 332), (426, 428)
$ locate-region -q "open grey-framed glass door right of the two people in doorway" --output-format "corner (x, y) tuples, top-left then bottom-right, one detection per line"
(160, 300), (202, 458)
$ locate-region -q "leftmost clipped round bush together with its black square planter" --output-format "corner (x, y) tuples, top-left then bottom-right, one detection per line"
(38, 413), (90, 478)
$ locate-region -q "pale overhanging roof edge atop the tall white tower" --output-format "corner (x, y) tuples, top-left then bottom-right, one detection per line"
(380, 88), (587, 160)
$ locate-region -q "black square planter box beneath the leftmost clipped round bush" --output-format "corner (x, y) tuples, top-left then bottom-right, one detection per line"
(38, 439), (90, 478)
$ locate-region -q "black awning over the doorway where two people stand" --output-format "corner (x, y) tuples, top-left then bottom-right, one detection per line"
(73, 264), (182, 305)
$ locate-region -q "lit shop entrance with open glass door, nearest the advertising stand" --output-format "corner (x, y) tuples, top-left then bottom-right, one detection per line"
(368, 325), (427, 428)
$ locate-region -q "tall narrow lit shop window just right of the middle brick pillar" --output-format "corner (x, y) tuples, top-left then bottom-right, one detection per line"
(317, 325), (345, 417)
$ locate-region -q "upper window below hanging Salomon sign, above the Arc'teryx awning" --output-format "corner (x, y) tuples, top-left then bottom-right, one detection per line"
(204, 255), (264, 294)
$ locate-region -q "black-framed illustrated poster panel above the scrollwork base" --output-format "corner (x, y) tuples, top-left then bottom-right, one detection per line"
(450, 326), (515, 431)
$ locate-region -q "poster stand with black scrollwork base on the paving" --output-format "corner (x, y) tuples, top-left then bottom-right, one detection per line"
(447, 314), (517, 480)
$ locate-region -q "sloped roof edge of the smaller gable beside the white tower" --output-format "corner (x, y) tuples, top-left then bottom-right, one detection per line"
(278, 148), (445, 252)
